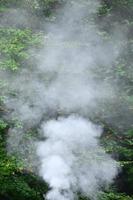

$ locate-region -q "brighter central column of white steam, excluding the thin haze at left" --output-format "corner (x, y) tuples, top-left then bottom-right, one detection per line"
(34, 0), (119, 200)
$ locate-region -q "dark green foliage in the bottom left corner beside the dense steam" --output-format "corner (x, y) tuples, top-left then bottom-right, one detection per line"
(0, 119), (48, 200)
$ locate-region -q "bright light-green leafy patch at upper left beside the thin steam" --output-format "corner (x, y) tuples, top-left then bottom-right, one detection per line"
(0, 28), (41, 71)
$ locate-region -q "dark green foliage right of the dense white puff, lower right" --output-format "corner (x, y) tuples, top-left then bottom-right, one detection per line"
(102, 129), (133, 193)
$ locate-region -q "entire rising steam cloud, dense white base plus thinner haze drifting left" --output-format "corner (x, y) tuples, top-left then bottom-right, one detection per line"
(0, 0), (125, 200)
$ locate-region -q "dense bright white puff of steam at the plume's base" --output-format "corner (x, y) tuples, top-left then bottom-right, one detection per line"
(37, 116), (117, 200)
